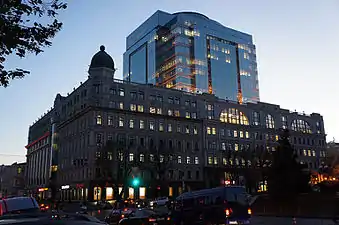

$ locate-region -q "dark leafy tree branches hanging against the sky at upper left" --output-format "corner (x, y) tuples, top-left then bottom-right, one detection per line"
(0, 0), (67, 87)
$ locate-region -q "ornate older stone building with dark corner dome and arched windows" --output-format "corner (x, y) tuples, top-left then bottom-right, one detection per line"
(25, 46), (325, 200)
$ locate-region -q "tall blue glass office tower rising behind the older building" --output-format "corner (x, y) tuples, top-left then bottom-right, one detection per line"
(123, 11), (259, 102)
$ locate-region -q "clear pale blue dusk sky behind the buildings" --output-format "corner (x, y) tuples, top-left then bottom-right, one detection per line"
(0, 0), (339, 164)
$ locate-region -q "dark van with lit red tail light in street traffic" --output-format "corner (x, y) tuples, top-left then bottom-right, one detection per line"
(173, 186), (252, 224)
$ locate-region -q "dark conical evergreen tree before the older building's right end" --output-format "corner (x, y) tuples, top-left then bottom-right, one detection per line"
(268, 130), (310, 199)
